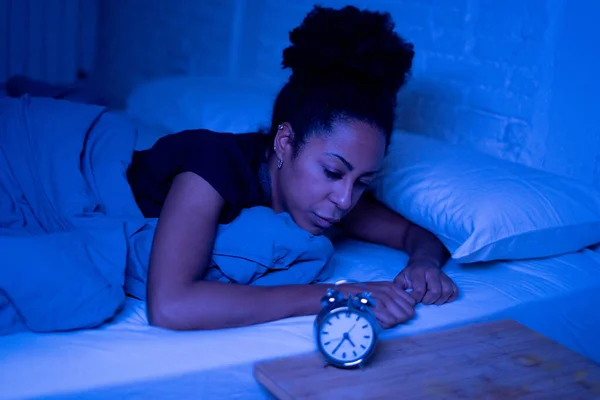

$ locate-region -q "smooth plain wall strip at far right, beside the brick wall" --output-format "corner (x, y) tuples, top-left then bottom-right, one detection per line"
(534, 0), (600, 186)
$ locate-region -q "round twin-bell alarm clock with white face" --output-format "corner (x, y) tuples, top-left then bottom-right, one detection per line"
(314, 281), (380, 368)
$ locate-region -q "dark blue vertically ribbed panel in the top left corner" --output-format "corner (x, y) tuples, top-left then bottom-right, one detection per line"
(0, 0), (97, 83)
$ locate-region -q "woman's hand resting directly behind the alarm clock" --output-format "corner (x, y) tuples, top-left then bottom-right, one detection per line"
(340, 282), (417, 329)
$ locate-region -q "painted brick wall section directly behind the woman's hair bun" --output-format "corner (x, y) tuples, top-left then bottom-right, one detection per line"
(251, 0), (560, 165)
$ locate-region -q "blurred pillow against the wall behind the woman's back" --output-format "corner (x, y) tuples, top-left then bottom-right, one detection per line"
(126, 76), (276, 133)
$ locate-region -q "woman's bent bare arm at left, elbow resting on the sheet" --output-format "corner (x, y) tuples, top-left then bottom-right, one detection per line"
(147, 172), (325, 330)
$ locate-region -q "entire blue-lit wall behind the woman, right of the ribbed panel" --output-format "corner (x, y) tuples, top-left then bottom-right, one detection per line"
(98, 0), (600, 185)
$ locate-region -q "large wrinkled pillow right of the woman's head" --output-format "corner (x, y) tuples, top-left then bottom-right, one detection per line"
(374, 132), (600, 263)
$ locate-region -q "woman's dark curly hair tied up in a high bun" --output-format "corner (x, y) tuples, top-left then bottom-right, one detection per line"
(270, 6), (414, 154)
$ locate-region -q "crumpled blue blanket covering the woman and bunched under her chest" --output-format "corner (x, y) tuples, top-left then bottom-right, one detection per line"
(0, 95), (333, 334)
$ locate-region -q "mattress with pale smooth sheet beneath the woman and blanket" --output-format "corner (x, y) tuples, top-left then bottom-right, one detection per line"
(0, 240), (600, 399)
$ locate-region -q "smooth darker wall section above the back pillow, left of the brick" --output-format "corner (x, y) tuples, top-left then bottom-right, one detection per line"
(96, 0), (238, 107)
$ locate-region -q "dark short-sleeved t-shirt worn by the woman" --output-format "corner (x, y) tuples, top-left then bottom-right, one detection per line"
(127, 129), (270, 223)
